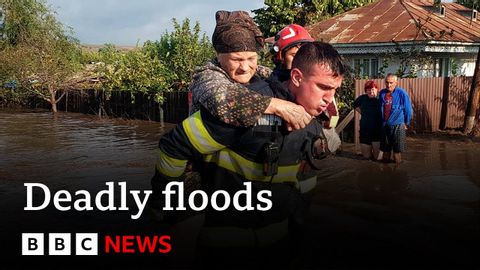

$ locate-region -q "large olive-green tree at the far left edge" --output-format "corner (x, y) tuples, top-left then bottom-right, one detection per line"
(0, 0), (80, 112)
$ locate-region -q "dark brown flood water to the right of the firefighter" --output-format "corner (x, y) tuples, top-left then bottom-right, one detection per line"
(306, 137), (480, 268)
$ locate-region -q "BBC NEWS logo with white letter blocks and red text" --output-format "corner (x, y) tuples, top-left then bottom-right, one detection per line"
(22, 233), (172, 256)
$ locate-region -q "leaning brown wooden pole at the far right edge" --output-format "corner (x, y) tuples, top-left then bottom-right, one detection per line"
(463, 48), (480, 134)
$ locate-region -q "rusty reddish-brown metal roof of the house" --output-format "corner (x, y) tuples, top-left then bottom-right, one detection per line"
(307, 0), (480, 44)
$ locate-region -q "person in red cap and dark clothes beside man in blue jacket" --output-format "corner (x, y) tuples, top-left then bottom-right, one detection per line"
(353, 81), (382, 160)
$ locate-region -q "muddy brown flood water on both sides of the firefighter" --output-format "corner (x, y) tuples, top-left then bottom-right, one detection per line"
(0, 111), (480, 269)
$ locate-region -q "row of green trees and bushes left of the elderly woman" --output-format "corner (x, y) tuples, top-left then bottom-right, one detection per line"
(0, 0), (214, 111)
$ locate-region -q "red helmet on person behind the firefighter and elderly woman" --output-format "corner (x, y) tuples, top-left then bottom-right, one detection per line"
(273, 24), (314, 61)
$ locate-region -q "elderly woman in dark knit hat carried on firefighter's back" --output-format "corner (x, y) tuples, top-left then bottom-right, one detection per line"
(189, 11), (312, 130)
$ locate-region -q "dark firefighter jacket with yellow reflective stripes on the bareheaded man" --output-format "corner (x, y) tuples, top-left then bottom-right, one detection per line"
(152, 74), (322, 245)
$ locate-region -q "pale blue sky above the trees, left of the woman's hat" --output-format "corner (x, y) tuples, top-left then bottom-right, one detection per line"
(46, 0), (264, 45)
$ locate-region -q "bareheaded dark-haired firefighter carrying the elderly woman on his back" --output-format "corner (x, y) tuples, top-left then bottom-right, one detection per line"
(150, 36), (346, 266)
